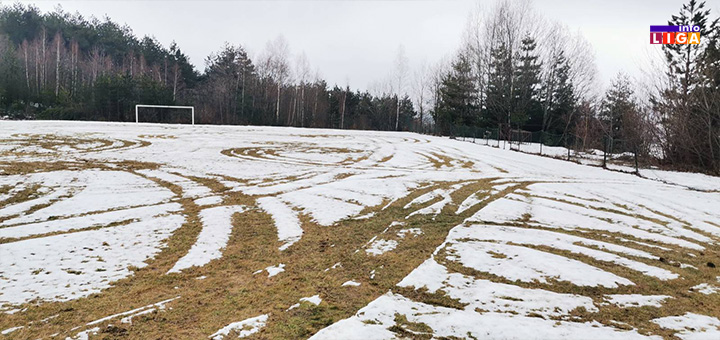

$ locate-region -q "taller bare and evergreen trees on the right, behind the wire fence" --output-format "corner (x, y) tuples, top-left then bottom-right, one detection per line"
(431, 0), (720, 174)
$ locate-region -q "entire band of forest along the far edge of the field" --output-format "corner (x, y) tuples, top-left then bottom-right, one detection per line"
(0, 0), (720, 173)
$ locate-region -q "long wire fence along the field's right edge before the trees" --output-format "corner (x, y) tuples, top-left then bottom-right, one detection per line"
(444, 126), (643, 173)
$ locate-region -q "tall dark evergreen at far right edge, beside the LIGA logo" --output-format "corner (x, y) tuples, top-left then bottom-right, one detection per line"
(652, 0), (720, 173)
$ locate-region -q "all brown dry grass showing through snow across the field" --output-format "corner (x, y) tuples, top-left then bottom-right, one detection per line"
(0, 136), (720, 339)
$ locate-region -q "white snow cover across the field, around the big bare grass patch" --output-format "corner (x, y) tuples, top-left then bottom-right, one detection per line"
(0, 121), (720, 339)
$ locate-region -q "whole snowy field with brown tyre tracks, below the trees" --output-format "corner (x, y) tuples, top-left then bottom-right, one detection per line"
(0, 121), (720, 339)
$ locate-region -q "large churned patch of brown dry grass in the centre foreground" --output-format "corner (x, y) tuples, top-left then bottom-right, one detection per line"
(0, 179), (504, 339)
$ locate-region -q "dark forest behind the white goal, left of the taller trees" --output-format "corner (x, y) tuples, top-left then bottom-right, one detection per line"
(0, 4), (416, 130)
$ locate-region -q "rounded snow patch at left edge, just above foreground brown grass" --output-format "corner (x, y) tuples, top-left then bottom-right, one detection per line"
(0, 215), (184, 305)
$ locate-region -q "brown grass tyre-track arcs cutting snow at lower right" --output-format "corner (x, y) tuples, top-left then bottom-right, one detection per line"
(435, 212), (720, 338)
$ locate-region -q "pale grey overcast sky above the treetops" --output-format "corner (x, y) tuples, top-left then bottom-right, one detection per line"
(14, 0), (720, 93)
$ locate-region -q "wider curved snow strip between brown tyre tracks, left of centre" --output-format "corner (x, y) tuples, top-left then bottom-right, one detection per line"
(168, 205), (245, 273)
